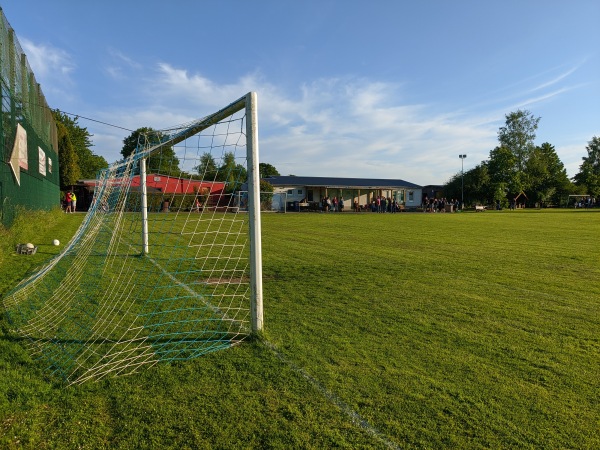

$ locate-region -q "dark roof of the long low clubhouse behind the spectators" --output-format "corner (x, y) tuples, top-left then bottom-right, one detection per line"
(264, 176), (421, 189)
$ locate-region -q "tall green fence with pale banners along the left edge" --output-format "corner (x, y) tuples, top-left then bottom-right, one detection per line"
(0, 9), (60, 227)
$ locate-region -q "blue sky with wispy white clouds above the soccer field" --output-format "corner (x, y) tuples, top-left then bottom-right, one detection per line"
(0, 0), (600, 185)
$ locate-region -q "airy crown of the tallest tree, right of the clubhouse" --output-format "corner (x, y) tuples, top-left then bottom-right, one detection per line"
(498, 109), (540, 176)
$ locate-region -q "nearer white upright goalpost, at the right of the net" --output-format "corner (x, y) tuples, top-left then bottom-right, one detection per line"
(246, 92), (263, 333)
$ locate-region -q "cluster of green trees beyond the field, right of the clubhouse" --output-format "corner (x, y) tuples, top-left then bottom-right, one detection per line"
(444, 110), (600, 207)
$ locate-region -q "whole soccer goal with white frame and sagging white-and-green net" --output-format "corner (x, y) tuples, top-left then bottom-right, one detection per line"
(3, 93), (263, 383)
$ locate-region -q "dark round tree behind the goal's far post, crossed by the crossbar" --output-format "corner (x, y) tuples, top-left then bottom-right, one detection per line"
(121, 127), (181, 177)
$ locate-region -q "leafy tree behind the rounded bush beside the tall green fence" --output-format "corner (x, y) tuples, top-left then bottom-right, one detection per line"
(52, 110), (108, 178)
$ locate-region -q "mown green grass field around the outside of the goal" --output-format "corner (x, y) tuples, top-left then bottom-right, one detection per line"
(0, 210), (600, 449)
